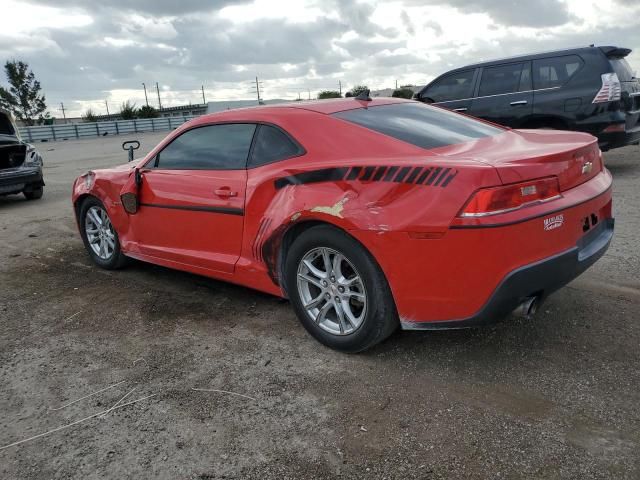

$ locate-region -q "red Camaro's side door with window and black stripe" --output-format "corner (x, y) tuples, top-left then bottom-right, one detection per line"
(131, 123), (256, 273)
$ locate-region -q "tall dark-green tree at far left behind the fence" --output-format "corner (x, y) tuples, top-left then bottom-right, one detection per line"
(0, 60), (48, 125)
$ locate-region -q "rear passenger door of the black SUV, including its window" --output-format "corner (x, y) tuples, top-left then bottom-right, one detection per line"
(468, 62), (533, 128)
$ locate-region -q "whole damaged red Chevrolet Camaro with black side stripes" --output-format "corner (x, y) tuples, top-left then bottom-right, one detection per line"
(73, 97), (613, 352)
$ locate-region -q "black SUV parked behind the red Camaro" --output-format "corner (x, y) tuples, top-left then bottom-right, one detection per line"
(415, 45), (640, 150)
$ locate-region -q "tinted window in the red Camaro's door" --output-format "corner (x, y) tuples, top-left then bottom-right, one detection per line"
(155, 123), (256, 170)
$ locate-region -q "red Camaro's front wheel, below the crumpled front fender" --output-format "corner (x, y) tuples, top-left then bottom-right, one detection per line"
(79, 198), (126, 270)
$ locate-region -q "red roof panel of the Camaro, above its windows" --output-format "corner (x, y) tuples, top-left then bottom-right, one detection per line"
(192, 97), (412, 123)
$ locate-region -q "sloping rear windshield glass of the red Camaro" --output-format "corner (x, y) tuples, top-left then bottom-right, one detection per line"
(333, 102), (504, 148)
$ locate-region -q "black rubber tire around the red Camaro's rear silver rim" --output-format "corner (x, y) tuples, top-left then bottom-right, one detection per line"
(284, 225), (399, 353)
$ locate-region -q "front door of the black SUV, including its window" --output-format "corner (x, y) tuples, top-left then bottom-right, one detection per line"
(417, 68), (478, 113)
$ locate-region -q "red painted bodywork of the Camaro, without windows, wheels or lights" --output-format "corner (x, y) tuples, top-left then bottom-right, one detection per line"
(73, 99), (611, 328)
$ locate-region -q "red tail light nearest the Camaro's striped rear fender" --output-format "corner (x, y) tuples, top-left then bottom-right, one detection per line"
(458, 177), (560, 217)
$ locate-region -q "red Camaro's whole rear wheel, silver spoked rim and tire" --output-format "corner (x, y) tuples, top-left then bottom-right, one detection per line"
(284, 225), (398, 352)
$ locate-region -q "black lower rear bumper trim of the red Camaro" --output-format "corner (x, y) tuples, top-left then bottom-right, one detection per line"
(401, 218), (614, 330)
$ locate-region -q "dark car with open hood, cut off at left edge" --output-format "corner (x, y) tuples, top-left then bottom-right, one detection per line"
(0, 110), (44, 200)
